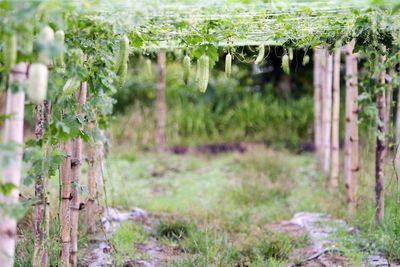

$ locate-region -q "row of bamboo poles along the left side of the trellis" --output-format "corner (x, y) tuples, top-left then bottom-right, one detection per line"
(0, 62), (103, 267)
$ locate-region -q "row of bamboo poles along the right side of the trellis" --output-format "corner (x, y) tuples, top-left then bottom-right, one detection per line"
(313, 42), (400, 223)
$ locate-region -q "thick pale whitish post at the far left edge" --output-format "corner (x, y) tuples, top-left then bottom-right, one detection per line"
(0, 62), (28, 267)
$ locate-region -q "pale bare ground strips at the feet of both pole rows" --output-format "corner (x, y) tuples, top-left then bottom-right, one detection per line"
(83, 208), (394, 267)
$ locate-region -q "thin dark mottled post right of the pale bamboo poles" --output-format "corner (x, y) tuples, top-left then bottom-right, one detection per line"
(375, 53), (386, 223)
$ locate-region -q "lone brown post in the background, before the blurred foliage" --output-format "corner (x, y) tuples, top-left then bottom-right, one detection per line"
(156, 51), (167, 152)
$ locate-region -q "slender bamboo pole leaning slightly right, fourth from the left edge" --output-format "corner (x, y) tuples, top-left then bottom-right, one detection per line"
(70, 82), (87, 266)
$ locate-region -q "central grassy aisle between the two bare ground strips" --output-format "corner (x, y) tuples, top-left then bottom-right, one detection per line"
(104, 148), (338, 266)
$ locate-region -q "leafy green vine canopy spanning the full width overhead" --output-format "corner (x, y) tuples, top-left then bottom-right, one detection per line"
(0, 0), (400, 71)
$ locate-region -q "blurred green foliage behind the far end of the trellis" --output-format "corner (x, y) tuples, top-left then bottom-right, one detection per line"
(111, 47), (313, 149)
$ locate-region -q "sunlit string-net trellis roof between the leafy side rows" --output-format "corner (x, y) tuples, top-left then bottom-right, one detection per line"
(86, 0), (399, 49)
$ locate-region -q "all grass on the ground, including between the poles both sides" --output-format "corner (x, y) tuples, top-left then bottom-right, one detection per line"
(16, 143), (400, 266)
